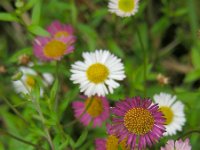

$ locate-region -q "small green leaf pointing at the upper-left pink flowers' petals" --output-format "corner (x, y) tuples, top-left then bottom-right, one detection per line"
(28, 25), (50, 36)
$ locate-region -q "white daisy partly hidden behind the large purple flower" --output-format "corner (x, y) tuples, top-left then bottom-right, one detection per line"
(154, 93), (186, 136)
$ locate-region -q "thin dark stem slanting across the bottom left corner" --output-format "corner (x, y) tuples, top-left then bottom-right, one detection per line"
(0, 130), (43, 149)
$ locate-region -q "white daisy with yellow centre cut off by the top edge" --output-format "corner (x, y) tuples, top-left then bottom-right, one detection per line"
(108, 0), (139, 17)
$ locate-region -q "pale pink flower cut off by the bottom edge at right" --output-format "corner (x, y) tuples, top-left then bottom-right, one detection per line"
(160, 139), (192, 150)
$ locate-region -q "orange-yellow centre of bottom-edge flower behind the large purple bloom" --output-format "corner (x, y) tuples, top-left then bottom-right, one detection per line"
(106, 135), (130, 150)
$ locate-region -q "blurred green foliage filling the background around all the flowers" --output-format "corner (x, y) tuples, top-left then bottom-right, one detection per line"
(0, 0), (200, 150)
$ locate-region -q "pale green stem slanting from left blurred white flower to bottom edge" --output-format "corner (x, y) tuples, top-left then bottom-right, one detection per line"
(20, 80), (55, 150)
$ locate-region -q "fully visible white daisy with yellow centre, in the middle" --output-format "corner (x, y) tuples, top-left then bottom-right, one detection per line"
(70, 50), (125, 96)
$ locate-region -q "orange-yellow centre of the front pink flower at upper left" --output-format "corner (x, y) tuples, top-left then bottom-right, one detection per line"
(44, 40), (66, 58)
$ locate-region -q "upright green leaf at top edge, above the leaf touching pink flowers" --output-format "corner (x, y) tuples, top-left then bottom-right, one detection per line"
(31, 1), (42, 25)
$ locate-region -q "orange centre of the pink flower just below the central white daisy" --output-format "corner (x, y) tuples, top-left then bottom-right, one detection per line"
(85, 96), (103, 117)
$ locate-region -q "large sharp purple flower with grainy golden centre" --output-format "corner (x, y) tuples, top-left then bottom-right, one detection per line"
(111, 97), (165, 150)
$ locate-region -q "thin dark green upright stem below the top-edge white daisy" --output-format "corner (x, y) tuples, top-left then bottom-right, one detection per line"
(136, 26), (147, 97)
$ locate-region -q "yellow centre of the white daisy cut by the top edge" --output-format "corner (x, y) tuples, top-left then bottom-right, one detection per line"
(118, 0), (135, 12)
